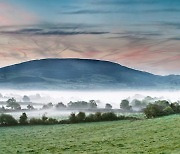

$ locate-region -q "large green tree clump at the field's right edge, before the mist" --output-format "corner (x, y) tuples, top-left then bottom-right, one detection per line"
(143, 100), (180, 118)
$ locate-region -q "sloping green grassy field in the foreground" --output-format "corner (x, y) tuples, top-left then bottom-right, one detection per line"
(0, 115), (180, 154)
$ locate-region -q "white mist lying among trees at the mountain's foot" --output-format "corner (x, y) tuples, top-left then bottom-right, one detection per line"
(0, 90), (180, 119)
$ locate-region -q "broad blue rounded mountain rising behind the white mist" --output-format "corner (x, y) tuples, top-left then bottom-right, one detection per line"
(0, 58), (180, 90)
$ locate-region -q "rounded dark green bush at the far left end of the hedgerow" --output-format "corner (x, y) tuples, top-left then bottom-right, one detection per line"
(0, 114), (18, 126)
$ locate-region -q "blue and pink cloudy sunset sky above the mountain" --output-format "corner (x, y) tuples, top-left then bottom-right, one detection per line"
(0, 0), (180, 75)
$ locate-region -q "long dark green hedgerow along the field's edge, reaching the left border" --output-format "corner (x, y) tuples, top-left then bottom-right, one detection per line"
(0, 112), (138, 126)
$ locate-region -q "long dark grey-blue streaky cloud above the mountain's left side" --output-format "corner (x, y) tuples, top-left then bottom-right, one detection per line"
(0, 24), (109, 36)
